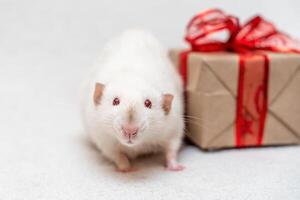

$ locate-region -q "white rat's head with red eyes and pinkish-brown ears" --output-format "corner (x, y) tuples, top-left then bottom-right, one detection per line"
(93, 80), (173, 146)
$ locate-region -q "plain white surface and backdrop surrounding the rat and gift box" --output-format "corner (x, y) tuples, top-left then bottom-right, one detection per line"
(0, 0), (300, 200)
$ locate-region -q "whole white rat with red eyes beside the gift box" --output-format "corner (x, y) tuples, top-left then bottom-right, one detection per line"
(81, 30), (184, 172)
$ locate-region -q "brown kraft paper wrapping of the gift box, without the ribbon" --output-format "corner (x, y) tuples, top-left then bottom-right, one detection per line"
(170, 49), (300, 149)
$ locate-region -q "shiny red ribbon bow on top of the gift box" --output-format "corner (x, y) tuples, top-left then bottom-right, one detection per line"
(185, 9), (300, 53)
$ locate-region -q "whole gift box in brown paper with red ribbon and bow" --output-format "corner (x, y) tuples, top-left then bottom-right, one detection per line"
(170, 10), (300, 149)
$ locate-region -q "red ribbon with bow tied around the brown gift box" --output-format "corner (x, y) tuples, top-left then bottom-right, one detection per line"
(180, 9), (300, 147)
